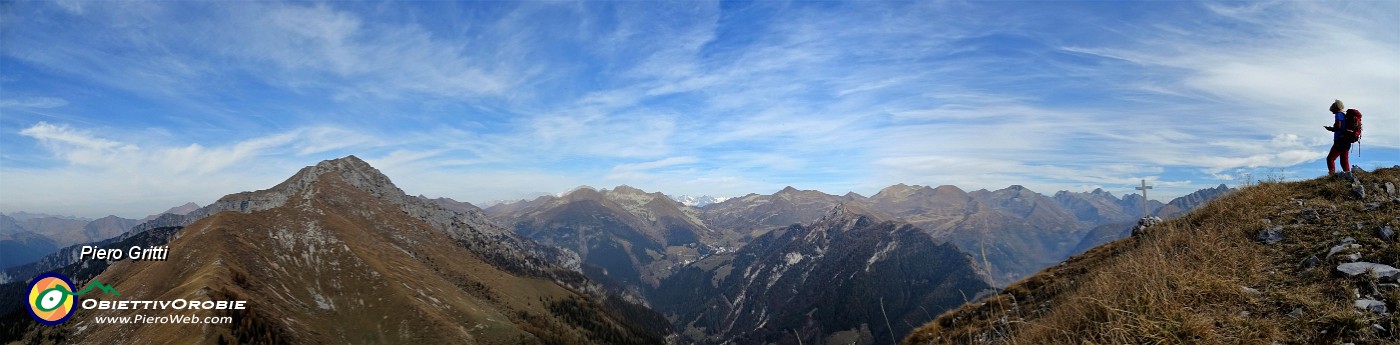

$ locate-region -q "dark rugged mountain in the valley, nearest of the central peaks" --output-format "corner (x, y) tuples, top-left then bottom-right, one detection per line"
(652, 205), (993, 344)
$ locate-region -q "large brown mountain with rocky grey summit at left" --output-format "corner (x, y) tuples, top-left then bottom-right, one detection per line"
(51, 156), (664, 344)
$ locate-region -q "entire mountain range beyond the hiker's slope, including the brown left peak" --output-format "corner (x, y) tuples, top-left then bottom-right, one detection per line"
(0, 156), (1229, 344)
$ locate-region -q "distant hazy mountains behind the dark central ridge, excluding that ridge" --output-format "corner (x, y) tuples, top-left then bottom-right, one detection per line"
(486, 184), (1231, 286)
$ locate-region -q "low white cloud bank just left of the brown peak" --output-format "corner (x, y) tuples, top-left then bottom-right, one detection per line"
(0, 122), (380, 217)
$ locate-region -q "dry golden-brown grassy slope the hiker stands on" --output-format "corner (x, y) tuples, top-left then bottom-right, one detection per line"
(904, 168), (1400, 344)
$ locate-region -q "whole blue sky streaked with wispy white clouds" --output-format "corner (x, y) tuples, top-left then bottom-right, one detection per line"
(0, 1), (1400, 217)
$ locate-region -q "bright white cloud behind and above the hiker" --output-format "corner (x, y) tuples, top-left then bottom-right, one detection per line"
(1065, 1), (1400, 147)
